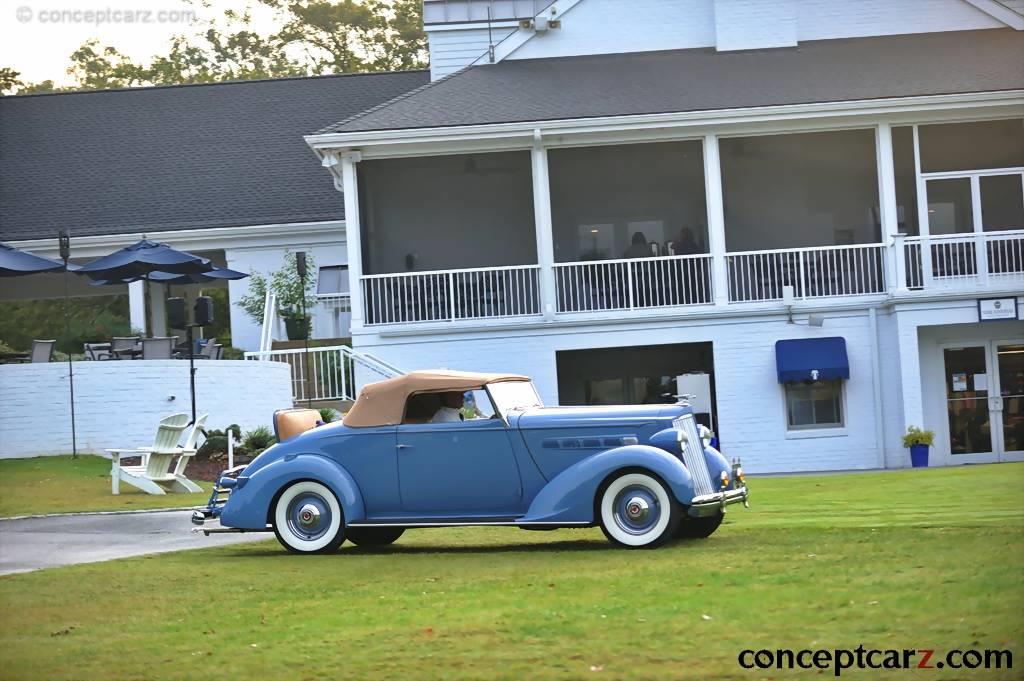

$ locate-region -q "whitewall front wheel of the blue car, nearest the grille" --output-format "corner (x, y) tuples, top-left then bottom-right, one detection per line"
(599, 472), (680, 549)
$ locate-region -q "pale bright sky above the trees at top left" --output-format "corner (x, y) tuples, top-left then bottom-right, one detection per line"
(0, 0), (276, 85)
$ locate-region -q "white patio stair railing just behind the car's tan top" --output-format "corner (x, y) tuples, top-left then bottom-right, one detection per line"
(245, 345), (402, 402)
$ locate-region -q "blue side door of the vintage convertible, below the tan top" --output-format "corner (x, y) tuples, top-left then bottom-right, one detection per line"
(397, 419), (524, 518)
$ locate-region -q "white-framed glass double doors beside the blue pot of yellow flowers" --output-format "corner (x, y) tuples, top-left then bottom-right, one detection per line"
(943, 340), (1024, 463)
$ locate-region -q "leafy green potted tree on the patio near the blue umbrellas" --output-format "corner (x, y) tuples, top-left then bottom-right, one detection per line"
(238, 252), (316, 340)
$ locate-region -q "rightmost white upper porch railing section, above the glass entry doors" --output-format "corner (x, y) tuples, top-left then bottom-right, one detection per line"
(897, 229), (1024, 289)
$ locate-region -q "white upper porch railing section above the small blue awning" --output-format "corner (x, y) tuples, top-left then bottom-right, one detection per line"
(725, 244), (886, 302)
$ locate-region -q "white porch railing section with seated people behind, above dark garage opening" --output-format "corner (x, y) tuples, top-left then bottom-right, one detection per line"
(554, 255), (715, 312)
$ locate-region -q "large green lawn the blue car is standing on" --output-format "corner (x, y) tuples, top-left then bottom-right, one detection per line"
(0, 464), (1024, 679)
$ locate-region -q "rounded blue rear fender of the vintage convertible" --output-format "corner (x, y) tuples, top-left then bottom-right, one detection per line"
(220, 454), (367, 529)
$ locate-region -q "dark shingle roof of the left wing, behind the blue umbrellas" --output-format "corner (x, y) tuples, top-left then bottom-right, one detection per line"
(0, 71), (429, 241)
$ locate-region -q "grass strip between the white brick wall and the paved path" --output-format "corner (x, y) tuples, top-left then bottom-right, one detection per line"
(0, 456), (211, 518)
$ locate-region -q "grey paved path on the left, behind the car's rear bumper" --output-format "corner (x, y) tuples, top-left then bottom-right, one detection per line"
(0, 510), (264, 574)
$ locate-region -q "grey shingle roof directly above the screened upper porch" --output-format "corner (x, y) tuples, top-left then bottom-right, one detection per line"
(321, 29), (1024, 133)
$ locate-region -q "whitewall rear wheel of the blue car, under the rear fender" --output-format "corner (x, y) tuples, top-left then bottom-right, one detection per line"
(273, 480), (345, 553)
